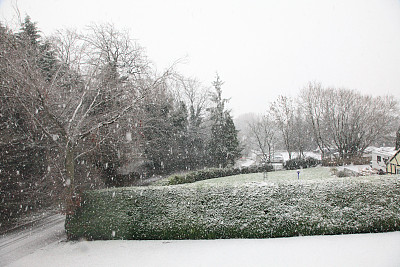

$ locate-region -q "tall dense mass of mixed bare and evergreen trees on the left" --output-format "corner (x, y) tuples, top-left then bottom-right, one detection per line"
(0, 16), (240, 226)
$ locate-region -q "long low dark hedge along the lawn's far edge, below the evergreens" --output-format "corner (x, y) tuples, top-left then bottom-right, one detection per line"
(167, 165), (273, 185)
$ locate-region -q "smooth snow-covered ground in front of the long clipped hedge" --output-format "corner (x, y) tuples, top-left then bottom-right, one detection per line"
(7, 232), (400, 267)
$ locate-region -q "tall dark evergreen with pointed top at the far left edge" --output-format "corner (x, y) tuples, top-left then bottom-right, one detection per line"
(0, 17), (55, 226)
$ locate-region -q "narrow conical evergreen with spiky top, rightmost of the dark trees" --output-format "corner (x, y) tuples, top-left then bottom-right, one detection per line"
(209, 75), (240, 167)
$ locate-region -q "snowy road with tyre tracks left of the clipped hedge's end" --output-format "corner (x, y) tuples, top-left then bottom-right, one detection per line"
(0, 214), (66, 266)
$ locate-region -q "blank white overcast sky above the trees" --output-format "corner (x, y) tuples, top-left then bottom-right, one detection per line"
(0, 0), (400, 116)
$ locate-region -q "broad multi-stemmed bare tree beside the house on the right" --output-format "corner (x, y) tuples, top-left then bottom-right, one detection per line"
(302, 83), (398, 159)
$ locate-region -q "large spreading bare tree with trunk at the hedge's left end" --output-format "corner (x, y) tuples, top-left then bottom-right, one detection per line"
(2, 19), (174, 215)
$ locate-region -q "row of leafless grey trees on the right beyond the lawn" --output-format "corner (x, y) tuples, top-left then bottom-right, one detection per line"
(247, 82), (400, 162)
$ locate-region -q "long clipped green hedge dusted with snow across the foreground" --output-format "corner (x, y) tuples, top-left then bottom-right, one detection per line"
(66, 176), (400, 239)
